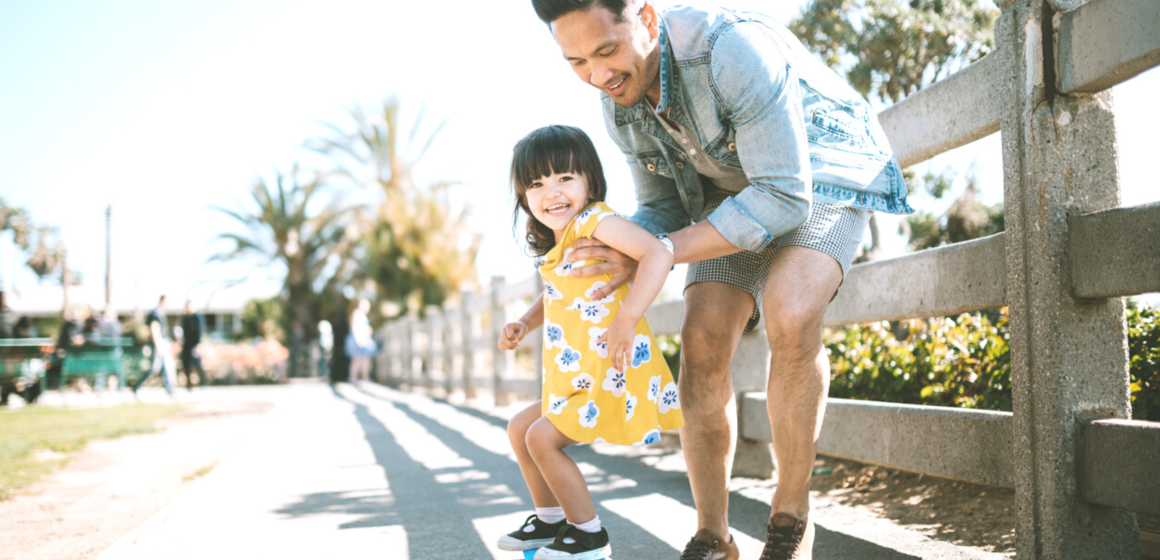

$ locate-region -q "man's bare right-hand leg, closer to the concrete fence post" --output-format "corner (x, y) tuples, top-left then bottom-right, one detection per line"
(760, 246), (842, 540)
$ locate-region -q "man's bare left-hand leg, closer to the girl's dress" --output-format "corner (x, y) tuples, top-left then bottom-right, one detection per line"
(677, 282), (755, 538)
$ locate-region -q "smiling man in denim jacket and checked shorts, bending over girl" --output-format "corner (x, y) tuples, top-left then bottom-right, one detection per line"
(532, 0), (912, 560)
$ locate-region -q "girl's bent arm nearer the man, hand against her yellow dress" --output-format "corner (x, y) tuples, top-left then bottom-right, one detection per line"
(593, 216), (674, 371)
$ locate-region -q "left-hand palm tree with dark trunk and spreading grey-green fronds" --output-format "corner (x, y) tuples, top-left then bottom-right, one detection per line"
(211, 168), (358, 377)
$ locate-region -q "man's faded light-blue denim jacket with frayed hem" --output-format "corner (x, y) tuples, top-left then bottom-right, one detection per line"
(601, 6), (913, 252)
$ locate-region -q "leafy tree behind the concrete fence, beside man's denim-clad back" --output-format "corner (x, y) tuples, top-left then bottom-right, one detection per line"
(789, 0), (1002, 261)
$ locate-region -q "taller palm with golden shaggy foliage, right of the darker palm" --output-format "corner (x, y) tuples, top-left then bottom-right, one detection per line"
(306, 97), (480, 313)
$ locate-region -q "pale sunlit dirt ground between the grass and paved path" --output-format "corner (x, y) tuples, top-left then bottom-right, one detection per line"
(0, 402), (270, 560)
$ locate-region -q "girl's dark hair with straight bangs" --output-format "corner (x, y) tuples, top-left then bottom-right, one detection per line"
(512, 124), (608, 256)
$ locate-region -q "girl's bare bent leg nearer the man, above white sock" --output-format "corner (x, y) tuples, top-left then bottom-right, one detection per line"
(528, 417), (596, 524)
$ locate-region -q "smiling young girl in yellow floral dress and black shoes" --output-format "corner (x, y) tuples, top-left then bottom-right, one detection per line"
(499, 126), (683, 560)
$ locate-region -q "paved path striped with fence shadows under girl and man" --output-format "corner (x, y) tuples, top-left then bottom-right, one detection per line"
(97, 384), (1007, 560)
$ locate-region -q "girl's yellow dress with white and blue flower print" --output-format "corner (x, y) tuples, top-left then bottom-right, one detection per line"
(539, 202), (684, 445)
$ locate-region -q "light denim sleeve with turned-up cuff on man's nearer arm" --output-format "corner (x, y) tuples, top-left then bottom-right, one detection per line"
(709, 22), (813, 252)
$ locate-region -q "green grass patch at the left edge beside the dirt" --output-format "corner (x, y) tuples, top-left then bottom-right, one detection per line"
(0, 403), (181, 500)
